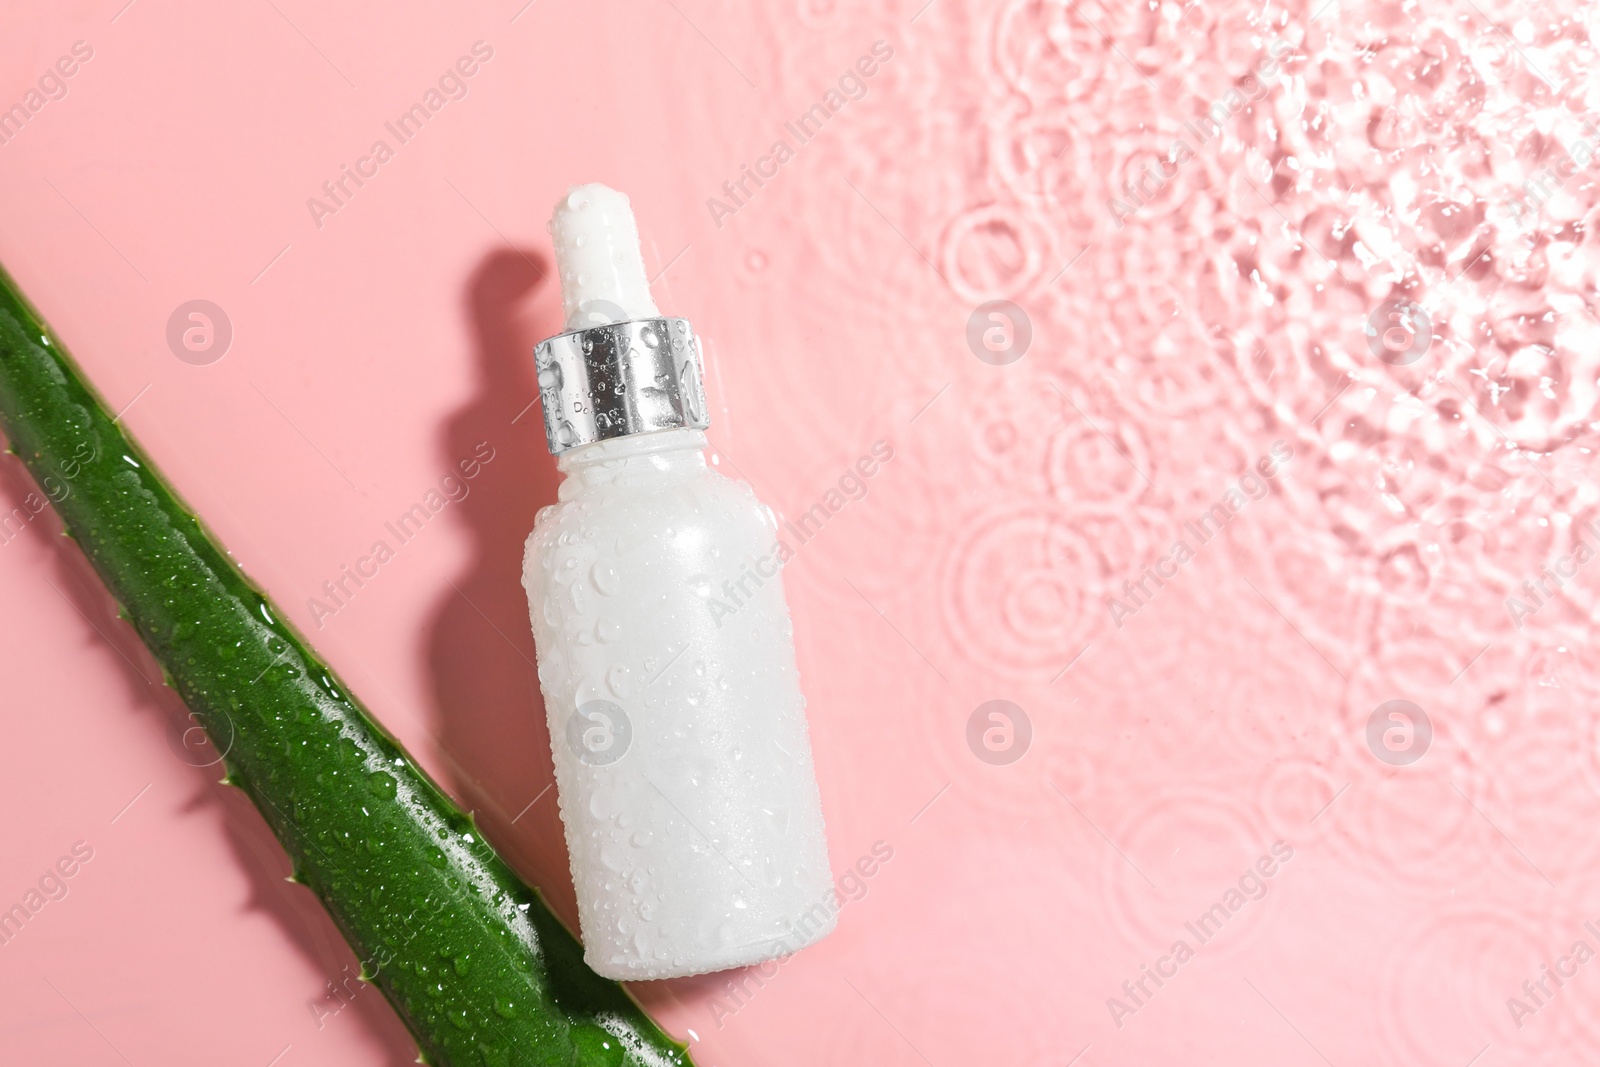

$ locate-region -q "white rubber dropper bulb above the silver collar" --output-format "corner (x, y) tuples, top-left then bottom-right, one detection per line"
(550, 182), (661, 331)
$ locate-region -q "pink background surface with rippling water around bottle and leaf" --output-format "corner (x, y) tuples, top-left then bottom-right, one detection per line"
(0, 0), (1600, 1067)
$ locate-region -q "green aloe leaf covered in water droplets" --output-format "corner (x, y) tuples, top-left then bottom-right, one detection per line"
(0, 270), (690, 1067)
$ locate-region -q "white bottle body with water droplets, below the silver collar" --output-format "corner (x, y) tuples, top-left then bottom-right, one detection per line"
(523, 429), (835, 979)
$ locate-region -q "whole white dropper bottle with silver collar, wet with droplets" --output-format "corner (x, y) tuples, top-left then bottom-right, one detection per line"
(522, 186), (837, 979)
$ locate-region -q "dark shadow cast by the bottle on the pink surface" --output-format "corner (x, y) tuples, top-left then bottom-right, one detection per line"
(427, 248), (578, 931)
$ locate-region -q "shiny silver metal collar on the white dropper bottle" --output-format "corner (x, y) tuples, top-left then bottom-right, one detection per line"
(533, 318), (710, 456)
